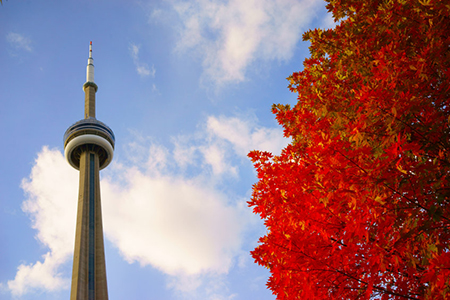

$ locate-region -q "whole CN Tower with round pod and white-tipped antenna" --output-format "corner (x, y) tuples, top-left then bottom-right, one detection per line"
(64, 42), (115, 300)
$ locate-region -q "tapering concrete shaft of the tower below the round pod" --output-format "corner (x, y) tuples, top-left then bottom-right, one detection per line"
(70, 144), (108, 300)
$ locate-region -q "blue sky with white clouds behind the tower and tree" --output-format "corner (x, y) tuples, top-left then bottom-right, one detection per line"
(0, 0), (332, 300)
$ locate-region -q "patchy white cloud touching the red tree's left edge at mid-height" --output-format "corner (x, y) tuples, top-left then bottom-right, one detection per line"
(174, 116), (289, 177)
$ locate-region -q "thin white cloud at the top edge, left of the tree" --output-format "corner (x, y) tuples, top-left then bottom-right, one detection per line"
(173, 0), (323, 84)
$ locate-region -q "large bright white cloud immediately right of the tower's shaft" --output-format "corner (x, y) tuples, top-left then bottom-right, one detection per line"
(102, 170), (245, 275)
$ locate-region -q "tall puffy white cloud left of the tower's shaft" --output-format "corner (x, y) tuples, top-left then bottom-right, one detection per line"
(7, 147), (78, 296)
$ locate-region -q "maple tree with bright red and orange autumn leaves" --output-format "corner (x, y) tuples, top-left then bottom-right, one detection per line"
(249, 0), (450, 299)
